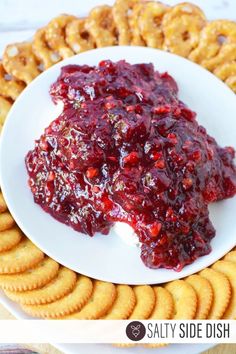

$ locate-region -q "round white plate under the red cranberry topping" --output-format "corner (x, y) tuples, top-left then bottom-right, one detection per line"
(0, 47), (236, 284)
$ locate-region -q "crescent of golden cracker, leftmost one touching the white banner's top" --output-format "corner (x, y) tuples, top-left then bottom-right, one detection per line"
(21, 275), (93, 318)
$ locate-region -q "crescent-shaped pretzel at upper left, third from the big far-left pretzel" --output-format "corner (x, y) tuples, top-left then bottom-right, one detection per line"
(45, 14), (76, 59)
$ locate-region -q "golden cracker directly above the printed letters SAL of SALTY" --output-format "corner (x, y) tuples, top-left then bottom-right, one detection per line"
(149, 286), (174, 320)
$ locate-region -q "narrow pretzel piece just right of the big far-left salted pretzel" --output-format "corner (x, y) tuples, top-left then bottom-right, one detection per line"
(32, 28), (61, 69)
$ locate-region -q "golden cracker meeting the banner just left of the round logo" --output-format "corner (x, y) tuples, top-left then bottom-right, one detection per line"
(103, 285), (136, 320)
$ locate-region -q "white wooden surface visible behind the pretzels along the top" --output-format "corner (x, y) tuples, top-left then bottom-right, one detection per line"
(0, 0), (236, 53)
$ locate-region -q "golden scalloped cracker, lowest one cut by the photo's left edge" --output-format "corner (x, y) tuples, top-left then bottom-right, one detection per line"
(0, 257), (59, 291)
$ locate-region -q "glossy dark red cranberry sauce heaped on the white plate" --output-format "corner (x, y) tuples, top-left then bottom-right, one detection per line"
(26, 61), (236, 271)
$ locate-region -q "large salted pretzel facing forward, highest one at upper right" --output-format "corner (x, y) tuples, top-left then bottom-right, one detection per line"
(162, 3), (206, 57)
